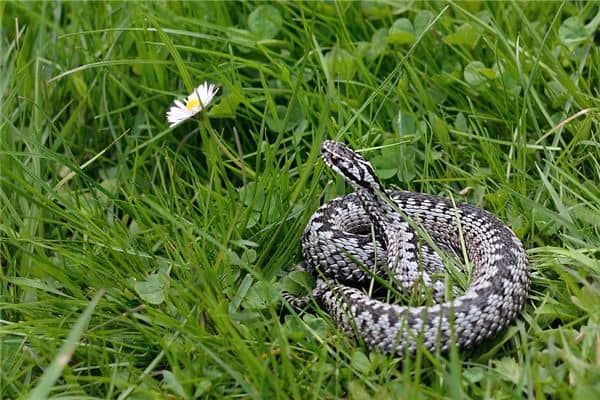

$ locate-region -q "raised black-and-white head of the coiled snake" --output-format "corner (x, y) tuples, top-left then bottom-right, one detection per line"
(321, 140), (380, 190)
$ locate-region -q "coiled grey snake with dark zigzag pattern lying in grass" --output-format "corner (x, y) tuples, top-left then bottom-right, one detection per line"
(284, 140), (530, 355)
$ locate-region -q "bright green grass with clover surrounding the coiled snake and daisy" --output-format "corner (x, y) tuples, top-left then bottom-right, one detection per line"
(0, 2), (600, 399)
